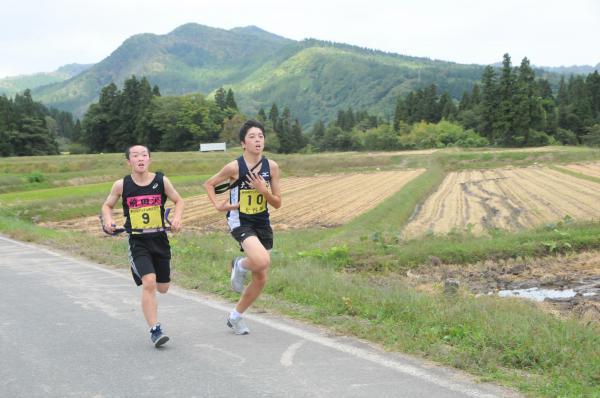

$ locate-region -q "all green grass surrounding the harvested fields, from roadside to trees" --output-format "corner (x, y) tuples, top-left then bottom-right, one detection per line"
(0, 147), (600, 397)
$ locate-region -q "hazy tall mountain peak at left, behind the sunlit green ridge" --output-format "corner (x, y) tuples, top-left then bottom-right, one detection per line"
(32, 24), (293, 115)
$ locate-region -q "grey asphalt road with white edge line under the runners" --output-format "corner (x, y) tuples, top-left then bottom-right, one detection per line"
(0, 236), (518, 398)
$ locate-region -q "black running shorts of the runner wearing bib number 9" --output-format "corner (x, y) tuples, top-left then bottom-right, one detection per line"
(129, 233), (171, 286)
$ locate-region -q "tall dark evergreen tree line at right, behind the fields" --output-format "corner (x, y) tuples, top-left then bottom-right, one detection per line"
(394, 54), (600, 146)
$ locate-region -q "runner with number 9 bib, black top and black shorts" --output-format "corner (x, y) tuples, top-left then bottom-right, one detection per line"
(100, 145), (184, 347)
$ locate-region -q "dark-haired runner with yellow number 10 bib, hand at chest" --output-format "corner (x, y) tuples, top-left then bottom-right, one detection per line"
(204, 120), (281, 335)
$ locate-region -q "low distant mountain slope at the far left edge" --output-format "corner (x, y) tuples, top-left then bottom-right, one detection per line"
(0, 64), (92, 96)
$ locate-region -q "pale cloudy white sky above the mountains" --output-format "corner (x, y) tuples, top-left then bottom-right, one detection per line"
(0, 0), (600, 78)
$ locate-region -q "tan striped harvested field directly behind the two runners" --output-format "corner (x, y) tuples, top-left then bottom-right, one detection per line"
(44, 169), (424, 234)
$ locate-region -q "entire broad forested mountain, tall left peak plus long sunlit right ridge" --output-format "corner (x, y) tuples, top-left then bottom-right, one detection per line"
(24, 23), (506, 126)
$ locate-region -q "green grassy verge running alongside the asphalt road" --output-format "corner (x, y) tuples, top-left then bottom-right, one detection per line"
(0, 211), (600, 397)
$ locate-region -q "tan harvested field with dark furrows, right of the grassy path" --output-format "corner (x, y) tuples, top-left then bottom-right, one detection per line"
(403, 167), (600, 237)
